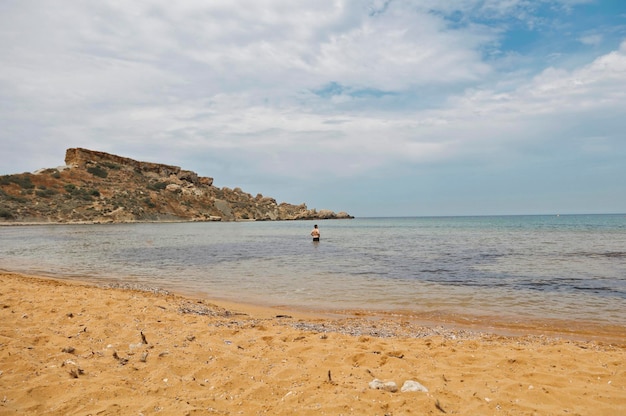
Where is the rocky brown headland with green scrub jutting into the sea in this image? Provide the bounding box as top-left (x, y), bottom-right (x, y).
top-left (0, 148), bottom-right (352, 223)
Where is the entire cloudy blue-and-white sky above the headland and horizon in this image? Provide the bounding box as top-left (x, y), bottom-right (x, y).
top-left (0, 0), bottom-right (626, 217)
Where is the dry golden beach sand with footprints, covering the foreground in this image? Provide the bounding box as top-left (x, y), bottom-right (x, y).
top-left (0, 272), bottom-right (626, 416)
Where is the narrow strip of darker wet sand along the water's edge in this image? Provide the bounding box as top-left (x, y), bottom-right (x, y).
top-left (0, 269), bottom-right (626, 347)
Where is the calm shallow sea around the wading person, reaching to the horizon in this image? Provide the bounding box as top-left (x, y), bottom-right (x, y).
top-left (0, 214), bottom-right (626, 326)
